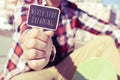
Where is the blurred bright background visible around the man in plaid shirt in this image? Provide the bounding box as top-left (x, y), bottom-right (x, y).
top-left (0, 0), bottom-right (120, 72)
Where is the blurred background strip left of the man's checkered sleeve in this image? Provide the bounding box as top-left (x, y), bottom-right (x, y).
top-left (0, 0), bottom-right (15, 72)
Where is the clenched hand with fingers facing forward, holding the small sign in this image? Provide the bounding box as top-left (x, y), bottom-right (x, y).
top-left (21, 28), bottom-right (53, 70)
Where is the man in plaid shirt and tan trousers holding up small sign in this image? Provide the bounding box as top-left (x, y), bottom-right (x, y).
top-left (1, 0), bottom-right (120, 80)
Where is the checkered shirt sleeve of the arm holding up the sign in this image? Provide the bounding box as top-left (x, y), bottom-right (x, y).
top-left (0, 0), bottom-right (41, 80)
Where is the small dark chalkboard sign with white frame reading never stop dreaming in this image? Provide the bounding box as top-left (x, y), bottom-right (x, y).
top-left (27, 4), bottom-right (60, 30)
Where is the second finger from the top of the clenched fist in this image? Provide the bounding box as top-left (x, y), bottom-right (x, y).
top-left (23, 38), bottom-right (47, 50)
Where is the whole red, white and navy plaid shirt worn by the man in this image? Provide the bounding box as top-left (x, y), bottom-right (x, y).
top-left (0, 0), bottom-right (120, 80)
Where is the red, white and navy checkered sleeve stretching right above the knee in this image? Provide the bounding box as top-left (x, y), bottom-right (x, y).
top-left (73, 9), bottom-right (120, 48)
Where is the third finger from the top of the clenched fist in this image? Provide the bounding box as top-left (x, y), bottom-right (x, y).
top-left (22, 49), bottom-right (46, 60)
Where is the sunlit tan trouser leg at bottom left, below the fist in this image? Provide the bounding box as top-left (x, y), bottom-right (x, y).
top-left (11, 67), bottom-right (55, 80)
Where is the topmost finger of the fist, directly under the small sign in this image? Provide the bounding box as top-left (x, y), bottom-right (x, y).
top-left (20, 28), bottom-right (54, 43)
